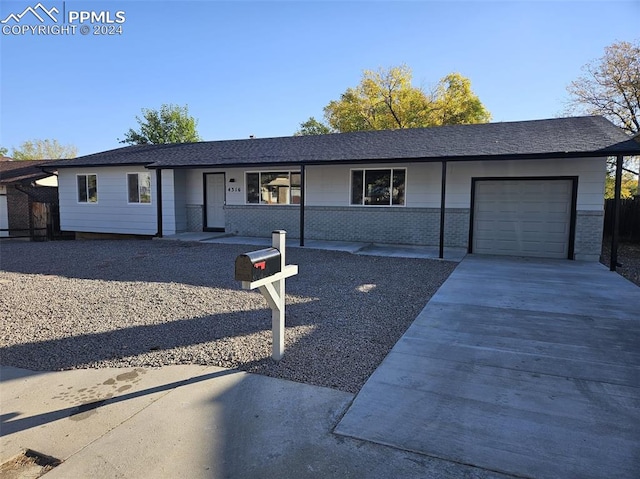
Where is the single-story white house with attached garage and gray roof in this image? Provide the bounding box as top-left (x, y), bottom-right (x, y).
top-left (46, 117), bottom-right (640, 260)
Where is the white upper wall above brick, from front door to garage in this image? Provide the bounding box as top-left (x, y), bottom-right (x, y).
top-left (178, 158), bottom-right (606, 211)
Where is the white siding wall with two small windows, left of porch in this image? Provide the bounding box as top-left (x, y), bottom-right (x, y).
top-left (58, 166), bottom-right (159, 235)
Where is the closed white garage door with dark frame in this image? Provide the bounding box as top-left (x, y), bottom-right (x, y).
top-left (473, 179), bottom-right (573, 259)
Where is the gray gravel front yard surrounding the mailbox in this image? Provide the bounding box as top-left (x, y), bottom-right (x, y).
top-left (0, 240), bottom-right (456, 393)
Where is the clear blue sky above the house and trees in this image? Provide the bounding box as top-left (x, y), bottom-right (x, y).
top-left (0, 0), bottom-right (640, 155)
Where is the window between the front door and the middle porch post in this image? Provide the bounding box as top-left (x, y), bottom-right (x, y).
top-left (246, 171), bottom-right (301, 205)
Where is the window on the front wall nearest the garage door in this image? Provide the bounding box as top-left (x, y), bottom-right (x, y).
top-left (351, 168), bottom-right (407, 206)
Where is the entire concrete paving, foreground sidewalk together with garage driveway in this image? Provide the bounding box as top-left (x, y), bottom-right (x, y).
top-left (0, 256), bottom-right (640, 479)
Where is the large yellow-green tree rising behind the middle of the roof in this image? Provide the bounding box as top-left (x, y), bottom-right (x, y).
top-left (296, 65), bottom-right (491, 135)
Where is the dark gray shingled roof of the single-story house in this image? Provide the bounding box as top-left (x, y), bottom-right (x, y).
top-left (47, 116), bottom-right (640, 168)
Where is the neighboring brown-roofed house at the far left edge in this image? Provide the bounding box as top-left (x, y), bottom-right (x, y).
top-left (0, 157), bottom-right (58, 237)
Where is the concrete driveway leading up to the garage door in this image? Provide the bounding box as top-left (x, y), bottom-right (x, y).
top-left (335, 256), bottom-right (640, 479)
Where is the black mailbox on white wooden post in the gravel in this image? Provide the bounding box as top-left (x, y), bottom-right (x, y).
top-left (236, 230), bottom-right (298, 361)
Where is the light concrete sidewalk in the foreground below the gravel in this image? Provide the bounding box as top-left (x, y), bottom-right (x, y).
top-left (0, 366), bottom-right (505, 479)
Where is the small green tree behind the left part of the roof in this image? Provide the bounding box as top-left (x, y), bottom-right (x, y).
top-left (118, 104), bottom-right (201, 145)
